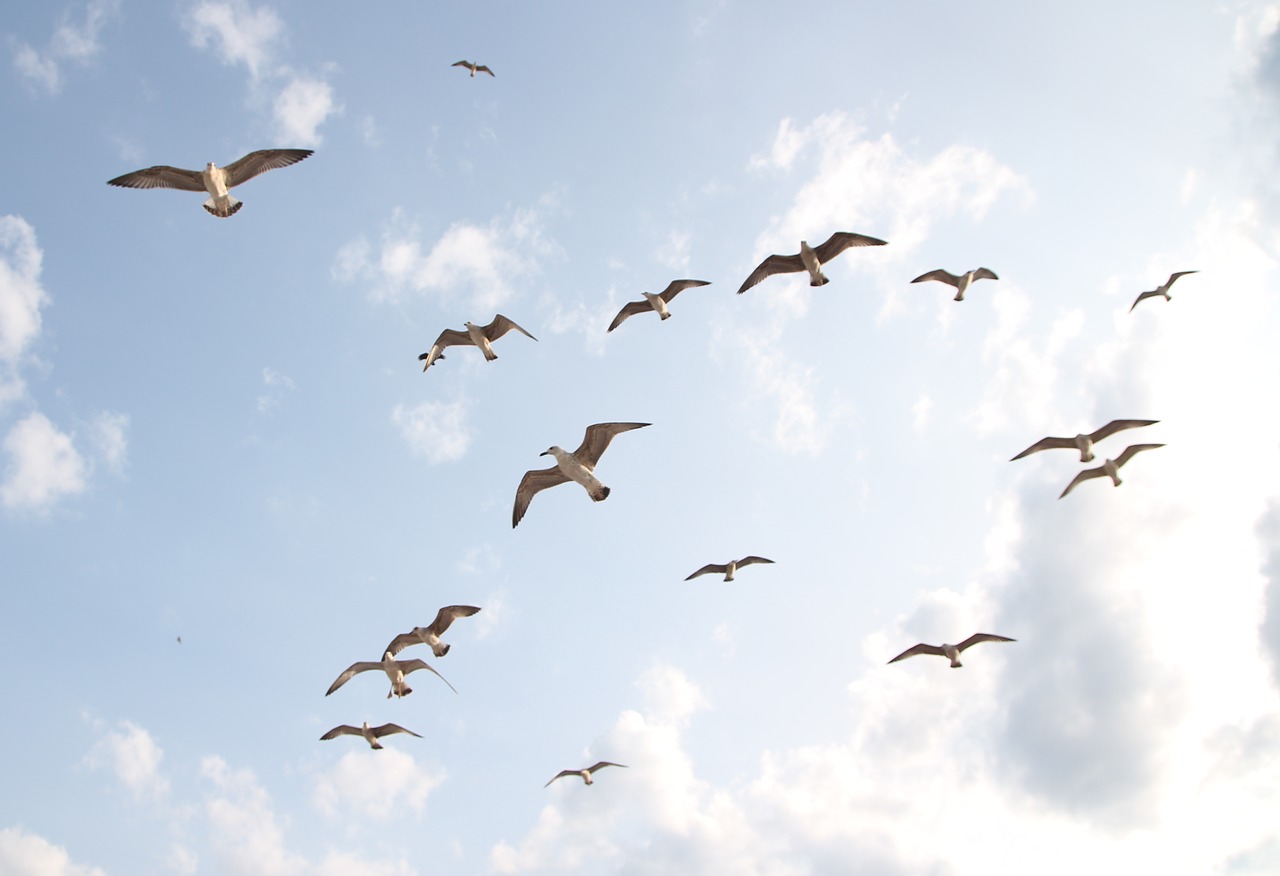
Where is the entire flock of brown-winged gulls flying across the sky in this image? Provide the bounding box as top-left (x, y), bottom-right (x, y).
top-left (108, 54), bottom-right (1197, 788)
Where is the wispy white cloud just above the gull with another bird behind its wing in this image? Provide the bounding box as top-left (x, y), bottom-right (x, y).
top-left (333, 197), bottom-right (559, 312)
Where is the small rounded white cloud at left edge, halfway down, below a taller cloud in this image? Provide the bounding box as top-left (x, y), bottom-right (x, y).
top-left (0, 412), bottom-right (87, 511)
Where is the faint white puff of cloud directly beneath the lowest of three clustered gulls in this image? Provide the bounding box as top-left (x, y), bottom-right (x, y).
top-left (311, 735), bottom-right (444, 820)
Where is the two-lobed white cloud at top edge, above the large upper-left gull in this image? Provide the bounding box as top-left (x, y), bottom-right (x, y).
top-left (183, 0), bottom-right (342, 146)
